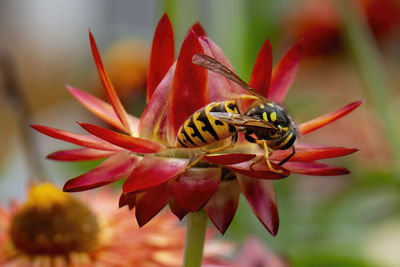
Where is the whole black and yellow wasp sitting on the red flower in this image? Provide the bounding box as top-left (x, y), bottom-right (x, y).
top-left (175, 54), bottom-right (297, 174)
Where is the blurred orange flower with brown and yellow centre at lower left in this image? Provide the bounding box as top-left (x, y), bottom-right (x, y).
top-left (0, 183), bottom-right (233, 267)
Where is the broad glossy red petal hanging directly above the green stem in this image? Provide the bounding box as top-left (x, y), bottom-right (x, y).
top-left (170, 168), bottom-right (221, 211)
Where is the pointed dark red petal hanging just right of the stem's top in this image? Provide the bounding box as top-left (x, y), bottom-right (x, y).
top-left (204, 180), bottom-right (240, 234)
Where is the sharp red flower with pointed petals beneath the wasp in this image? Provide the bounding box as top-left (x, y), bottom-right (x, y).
top-left (32, 15), bottom-right (361, 235)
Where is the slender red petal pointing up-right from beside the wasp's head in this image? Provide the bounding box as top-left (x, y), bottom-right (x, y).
top-left (298, 100), bottom-right (364, 135)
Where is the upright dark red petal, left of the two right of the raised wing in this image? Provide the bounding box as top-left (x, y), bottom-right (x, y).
top-left (249, 39), bottom-right (272, 97)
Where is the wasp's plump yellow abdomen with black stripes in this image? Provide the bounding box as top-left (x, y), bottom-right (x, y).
top-left (175, 101), bottom-right (239, 148)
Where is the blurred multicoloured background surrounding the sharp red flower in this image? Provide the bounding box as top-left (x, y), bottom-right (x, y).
top-left (0, 0), bottom-right (400, 266)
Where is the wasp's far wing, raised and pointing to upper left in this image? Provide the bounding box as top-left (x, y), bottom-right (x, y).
top-left (192, 54), bottom-right (267, 100)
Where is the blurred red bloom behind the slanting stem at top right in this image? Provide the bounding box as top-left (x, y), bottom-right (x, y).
top-left (285, 0), bottom-right (400, 56)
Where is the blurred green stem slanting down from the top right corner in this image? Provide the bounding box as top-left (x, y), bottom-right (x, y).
top-left (336, 0), bottom-right (400, 177)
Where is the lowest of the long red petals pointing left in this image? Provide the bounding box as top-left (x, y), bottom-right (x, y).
top-left (64, 152), bottom-right (139, 192)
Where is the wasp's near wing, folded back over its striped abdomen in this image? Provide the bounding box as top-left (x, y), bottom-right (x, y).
top-left (208, 112), bottom-right (276, 129)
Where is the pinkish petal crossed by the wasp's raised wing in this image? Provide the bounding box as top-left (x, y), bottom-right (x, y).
top-left (199, 36), bottom-right (245, 104)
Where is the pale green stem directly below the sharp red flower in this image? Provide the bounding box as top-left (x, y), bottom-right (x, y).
top-left (182, 210), bottom-right (207, 267)
